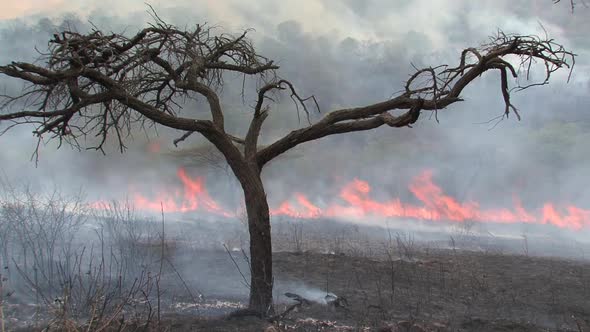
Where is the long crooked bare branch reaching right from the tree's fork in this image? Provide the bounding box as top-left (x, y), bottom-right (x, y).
top-left (257, 31), bottom-right (575, 167)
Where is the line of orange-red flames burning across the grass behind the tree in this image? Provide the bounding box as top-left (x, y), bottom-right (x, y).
top-left (91, 168), bottom-right (590, 230)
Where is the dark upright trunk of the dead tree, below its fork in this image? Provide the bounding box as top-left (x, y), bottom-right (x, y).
top-left (239, 170), bottom-right (273, 316)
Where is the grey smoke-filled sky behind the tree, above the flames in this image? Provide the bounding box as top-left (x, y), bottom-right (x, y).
top-left (0, 0), bottom-right (590, 237)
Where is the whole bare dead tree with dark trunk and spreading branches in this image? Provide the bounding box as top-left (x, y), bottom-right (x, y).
top-left (0, 14), bottom-right (574, 315)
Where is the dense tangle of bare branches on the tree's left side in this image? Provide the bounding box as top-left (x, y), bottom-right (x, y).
top-left (0, 20), bottom-right (278, 155)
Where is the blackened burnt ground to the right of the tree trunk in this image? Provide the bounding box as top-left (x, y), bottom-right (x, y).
top-left (276, 250), bottom-right (590, 331)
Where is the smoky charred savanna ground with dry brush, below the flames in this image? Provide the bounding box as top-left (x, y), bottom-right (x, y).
top-left (2, 202), bottom-right (590, 332)
